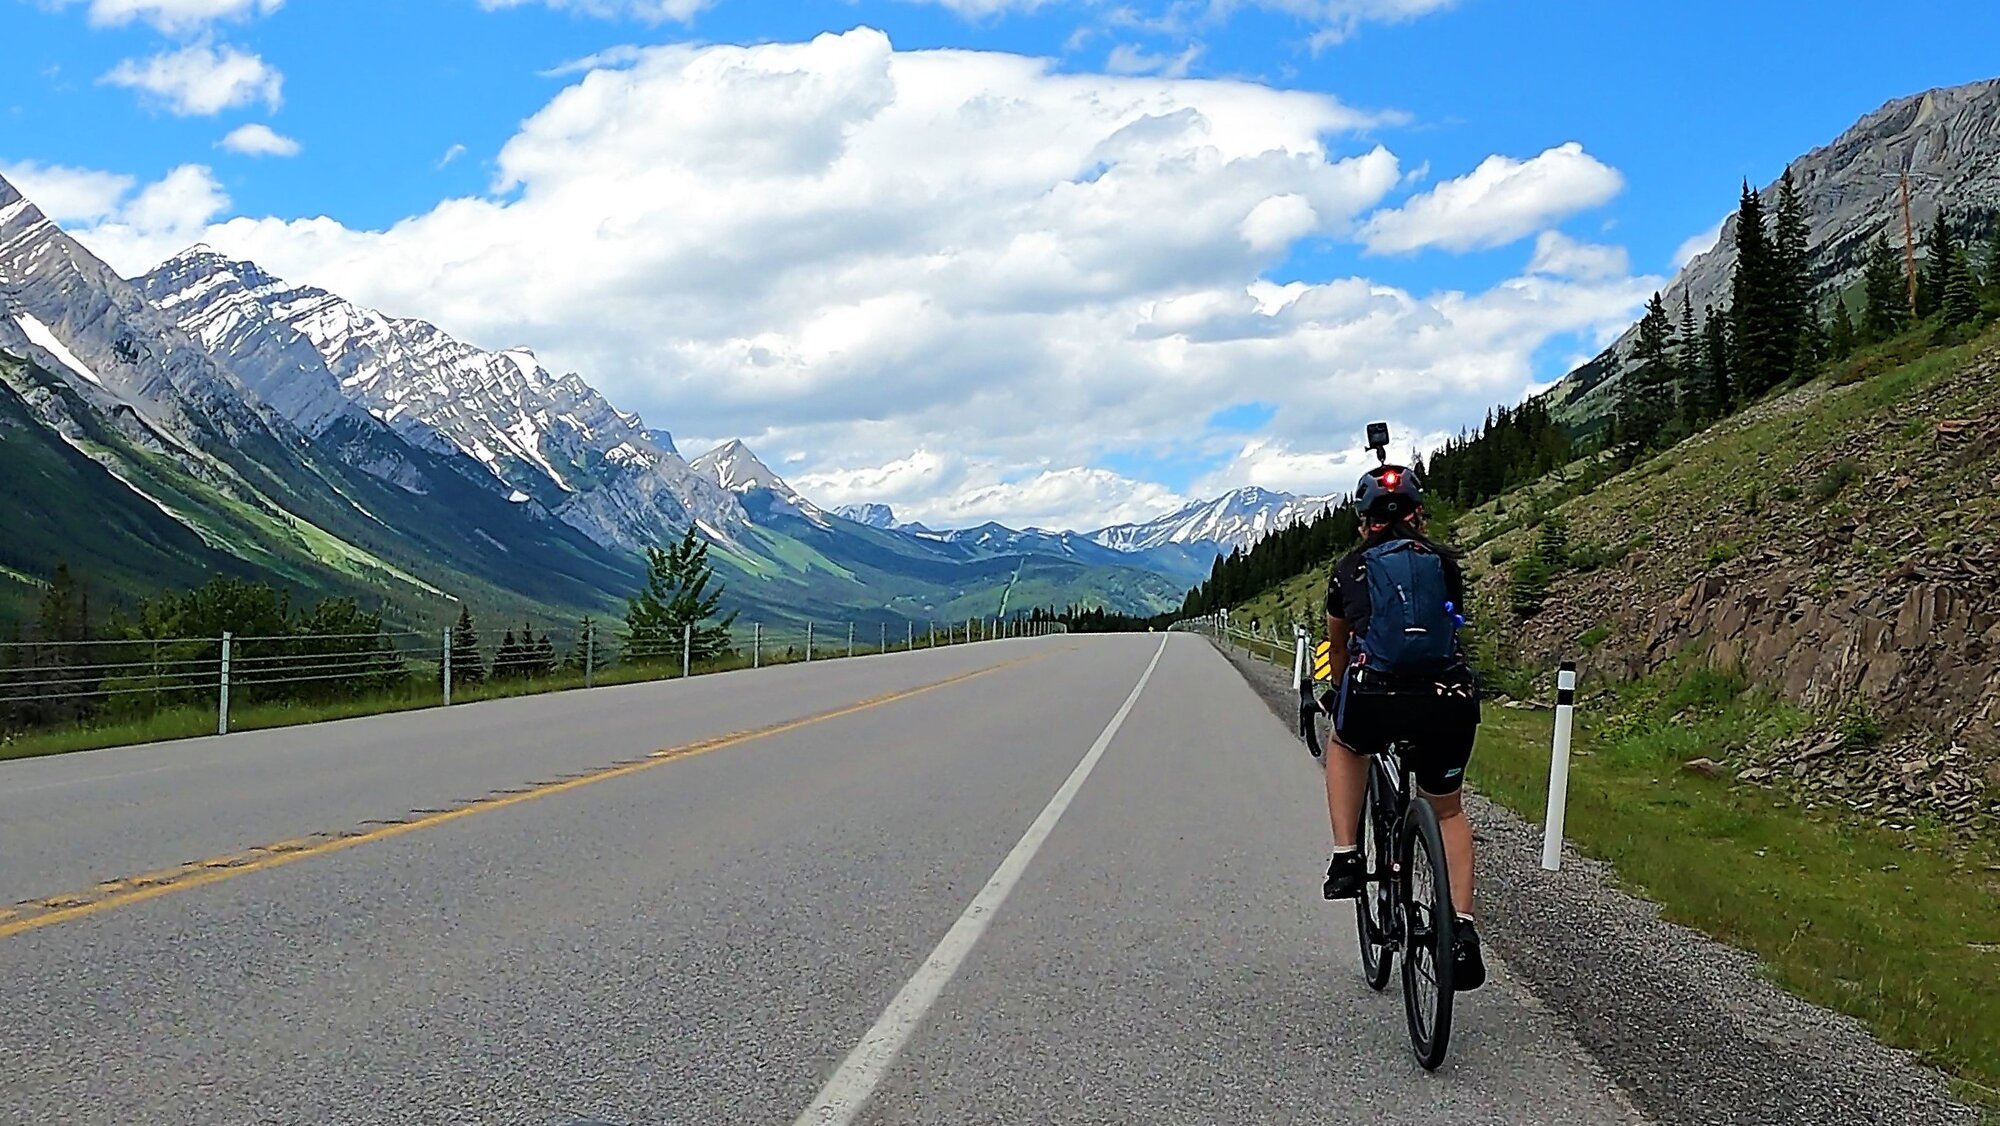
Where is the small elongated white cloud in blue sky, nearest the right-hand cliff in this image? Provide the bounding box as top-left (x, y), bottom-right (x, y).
top-left (1362, 142), bottom-right (1624, 254)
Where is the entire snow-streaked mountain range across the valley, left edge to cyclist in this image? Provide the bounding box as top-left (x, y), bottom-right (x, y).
top-left (0, 180), bottom-right (1360, 636)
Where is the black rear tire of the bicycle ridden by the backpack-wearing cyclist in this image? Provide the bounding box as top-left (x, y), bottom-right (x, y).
top-left (1396, 796), bottom-right (1458, 1072)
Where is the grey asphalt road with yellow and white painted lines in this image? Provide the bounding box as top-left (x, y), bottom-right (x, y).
top-left (0, 636), bottom-right (1636, 1126)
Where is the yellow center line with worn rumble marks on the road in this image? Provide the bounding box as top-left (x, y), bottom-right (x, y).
top-left (0, 654), bottom-right (1050, 938)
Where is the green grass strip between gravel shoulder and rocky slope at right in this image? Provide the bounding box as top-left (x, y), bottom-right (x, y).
top-left (1468, 692), bottom-right (2000, 1120)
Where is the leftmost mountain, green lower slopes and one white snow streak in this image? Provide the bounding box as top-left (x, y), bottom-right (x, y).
top-left (0, 172), bottom-right (634, 620)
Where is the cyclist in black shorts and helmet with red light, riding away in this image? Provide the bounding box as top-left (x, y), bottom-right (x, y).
top-left (1326, 464), bottom-right (1486, 990)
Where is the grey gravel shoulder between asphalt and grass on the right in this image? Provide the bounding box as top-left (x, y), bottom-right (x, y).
top-left (1228, 640), bottom-right (1980, 1126)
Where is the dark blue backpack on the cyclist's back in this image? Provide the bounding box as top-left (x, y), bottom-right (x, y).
top-left (1354, 540), bottom-right (1458, 676)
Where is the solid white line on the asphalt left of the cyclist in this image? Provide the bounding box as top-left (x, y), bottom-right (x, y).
top-left (794, 636), bottom-right (1168, 1126)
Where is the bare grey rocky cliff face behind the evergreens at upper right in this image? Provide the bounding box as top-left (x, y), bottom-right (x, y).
top-left (1550, 78), bottom-right (2000, 420)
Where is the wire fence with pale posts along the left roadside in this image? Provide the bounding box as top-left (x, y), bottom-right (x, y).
top-left (0, 618), bottom-right (1068, 744)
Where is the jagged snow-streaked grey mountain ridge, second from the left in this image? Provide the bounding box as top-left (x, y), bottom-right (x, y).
top-left (138, 246), bottom-right (744, 548)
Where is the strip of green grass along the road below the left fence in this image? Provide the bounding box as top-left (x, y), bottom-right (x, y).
top-left (0, 642), bottom-right (966, 762)
